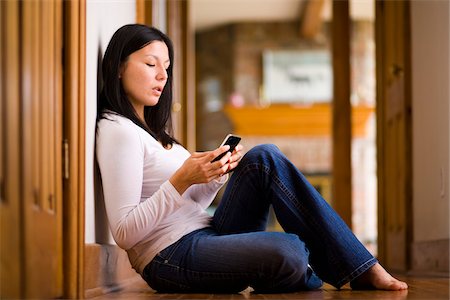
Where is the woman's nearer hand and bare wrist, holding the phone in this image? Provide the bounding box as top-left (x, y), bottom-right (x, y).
top-left (169, 145), bottom-right (231, 195)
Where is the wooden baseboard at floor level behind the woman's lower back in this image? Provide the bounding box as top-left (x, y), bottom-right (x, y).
top-left (84, 244), bottom-right (148, 298)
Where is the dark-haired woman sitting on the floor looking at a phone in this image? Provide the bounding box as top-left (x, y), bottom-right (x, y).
top-left (96, 25), bottom-right (407, 293)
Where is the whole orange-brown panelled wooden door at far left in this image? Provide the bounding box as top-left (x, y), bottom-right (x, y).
top-left (1, 0), bottom-right (63, 299)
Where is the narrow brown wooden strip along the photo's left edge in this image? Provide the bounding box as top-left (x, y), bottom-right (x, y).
top-left (0, 1), bottom-right (25, 299)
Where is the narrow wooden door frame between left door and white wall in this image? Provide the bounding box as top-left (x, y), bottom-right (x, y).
top-left (64, 0), bottom-right (86, 299)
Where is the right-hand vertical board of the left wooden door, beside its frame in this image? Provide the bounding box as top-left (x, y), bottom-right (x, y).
top-left (21, 1), bottom-right (62, 298)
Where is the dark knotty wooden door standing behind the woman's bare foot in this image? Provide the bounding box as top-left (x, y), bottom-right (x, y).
top-left (376, 1), bottom-right (412, 271)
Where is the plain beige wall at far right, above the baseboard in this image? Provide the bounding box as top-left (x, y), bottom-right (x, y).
top-left (411, 1), bottom-right (450, 242)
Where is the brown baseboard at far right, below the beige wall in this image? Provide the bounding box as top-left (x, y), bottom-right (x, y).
top-left (411, 239), bottom-right (450, 277)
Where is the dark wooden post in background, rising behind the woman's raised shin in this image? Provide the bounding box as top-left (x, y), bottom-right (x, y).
top-left (332, 0), bottom-right (352, 228)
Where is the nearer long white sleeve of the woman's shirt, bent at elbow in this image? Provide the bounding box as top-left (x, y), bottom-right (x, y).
top-left (96, 120), bottom-right (192, 250)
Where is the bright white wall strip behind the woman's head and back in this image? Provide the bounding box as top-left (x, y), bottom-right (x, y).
top-left (85, 0), bottom-right (136, 243)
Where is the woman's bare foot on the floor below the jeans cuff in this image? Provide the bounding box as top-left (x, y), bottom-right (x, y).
top-left (350, 263), bottom-right (408, 291)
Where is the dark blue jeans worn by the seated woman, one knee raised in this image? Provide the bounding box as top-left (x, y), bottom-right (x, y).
top-left (143, 145), bottom-right (377, 293)
